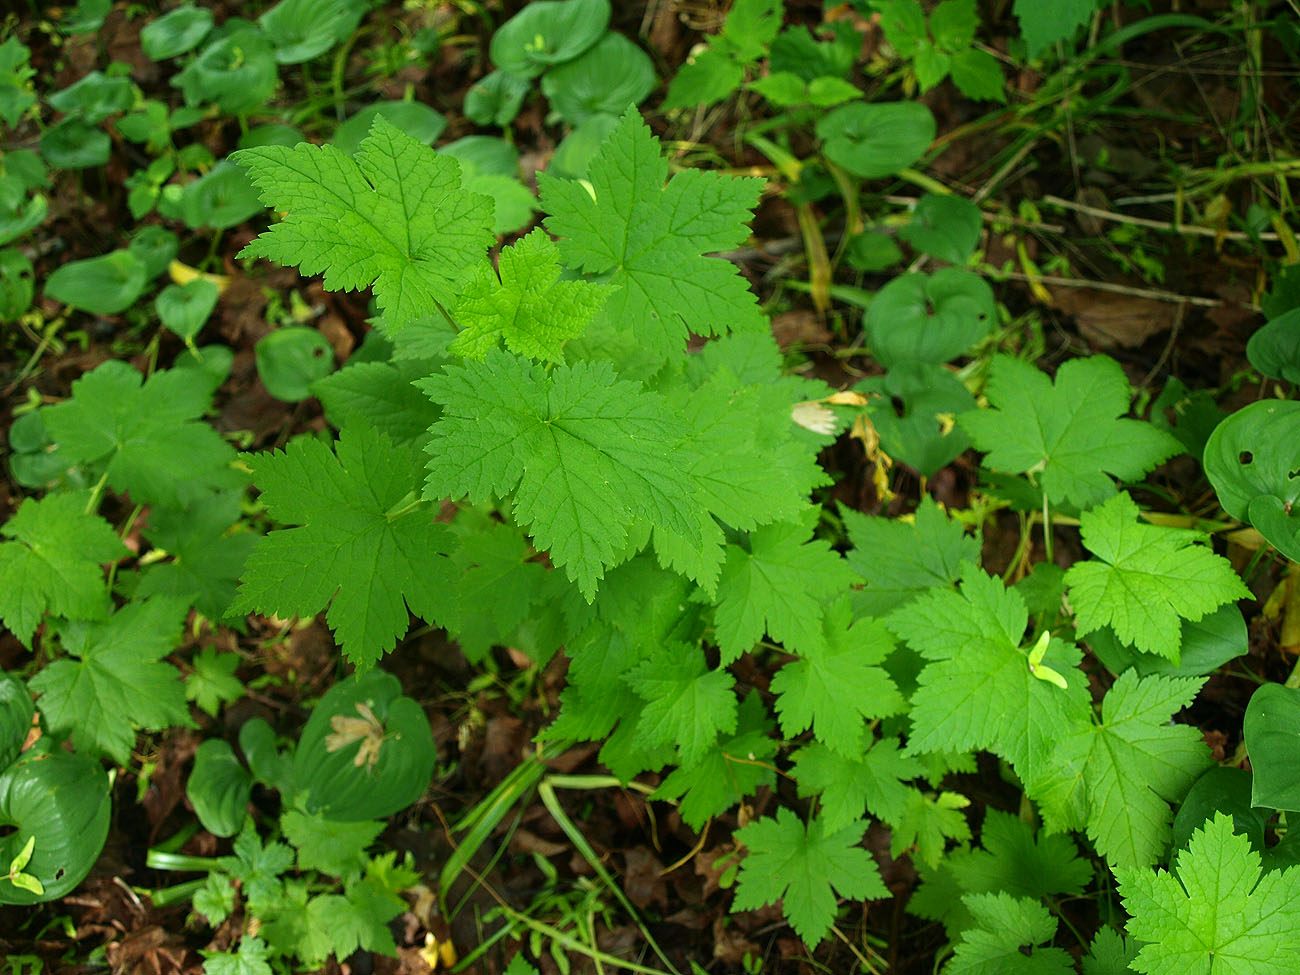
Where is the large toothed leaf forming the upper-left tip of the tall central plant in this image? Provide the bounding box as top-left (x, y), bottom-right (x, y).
top-left (230, 116), bottom-right (493, 332)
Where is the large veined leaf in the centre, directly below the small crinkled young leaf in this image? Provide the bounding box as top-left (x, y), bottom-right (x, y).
top-left (417, 351), bottom-right (707, 601)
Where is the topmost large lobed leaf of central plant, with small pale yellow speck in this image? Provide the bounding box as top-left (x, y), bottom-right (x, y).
top-left (538, 112), bottom-right (767, 359)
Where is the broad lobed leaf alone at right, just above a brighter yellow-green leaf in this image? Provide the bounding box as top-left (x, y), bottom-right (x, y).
top-left (958, 355), bottom-right (1183, 508)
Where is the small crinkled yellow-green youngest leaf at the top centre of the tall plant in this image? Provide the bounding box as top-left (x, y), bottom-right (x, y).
top-left (449, 229), bottom-right (610, 363)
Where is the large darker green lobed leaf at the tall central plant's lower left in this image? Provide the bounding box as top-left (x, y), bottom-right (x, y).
top-left (233, 424), bottom-right (454, 667)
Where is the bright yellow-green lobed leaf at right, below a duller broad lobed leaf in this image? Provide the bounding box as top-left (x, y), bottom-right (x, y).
top-left (1065, 494), bottom-right (1251, 662)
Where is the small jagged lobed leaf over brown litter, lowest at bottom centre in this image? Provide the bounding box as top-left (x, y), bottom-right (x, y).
top-left (732, 809), bottom-right (889, 946)
